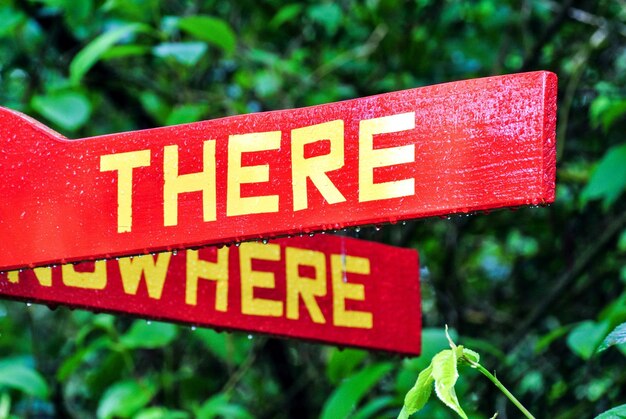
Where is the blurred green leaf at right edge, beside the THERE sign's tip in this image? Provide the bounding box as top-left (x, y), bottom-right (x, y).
top-left (582, 143), bottom-right (626, 208)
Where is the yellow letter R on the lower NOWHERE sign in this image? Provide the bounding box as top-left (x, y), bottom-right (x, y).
top-left (285, 247), bottom-right (326, 323)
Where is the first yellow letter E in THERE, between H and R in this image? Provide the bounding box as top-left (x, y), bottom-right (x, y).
top-left (226, 131), bottom-right (281, 217)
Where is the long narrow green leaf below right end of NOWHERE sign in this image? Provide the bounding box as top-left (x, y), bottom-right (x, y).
top-left (320, 363), bottom-right (393, 419)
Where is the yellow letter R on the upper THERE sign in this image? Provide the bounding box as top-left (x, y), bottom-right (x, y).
top-left (291, 119), bottom-right (346, 211)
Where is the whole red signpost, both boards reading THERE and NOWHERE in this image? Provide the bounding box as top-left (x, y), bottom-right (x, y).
top-left (0, 72), bottom-right (556, 355)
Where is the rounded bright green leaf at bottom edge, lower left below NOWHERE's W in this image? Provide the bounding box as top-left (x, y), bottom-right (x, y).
top-left (97, 380), bottom-right (157, 419)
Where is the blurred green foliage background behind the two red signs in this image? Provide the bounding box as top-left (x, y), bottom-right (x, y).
top-left (0, 0), bottom-right (626, 419)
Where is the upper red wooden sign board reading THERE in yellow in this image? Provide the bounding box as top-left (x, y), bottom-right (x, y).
top-left (0, 72), bottom-right (556, 270)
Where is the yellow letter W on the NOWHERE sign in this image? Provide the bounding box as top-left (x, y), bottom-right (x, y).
top-left (118, 253), bottom-right (172, 300)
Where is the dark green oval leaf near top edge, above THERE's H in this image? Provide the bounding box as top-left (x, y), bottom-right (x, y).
top-left (178, 16), bottom-right (237, 54)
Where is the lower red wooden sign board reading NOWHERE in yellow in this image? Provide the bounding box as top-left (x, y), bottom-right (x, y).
top-left (0, 234), bottom-right (421, 355)
